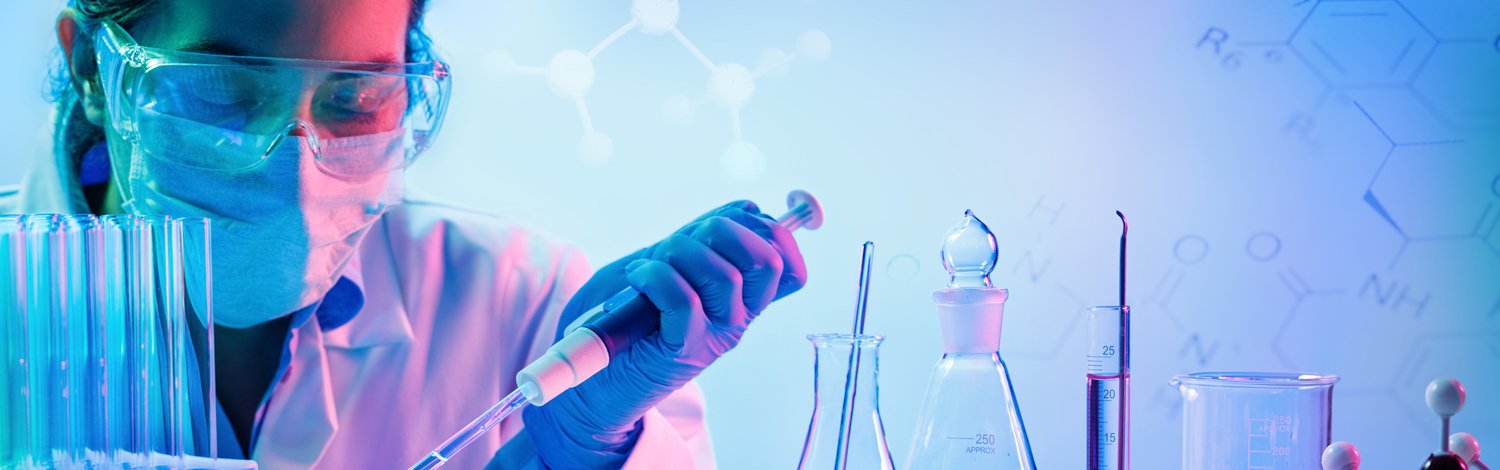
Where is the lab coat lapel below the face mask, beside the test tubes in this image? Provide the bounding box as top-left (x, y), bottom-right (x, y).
top-left (251, 315), bottom-right (339, 468)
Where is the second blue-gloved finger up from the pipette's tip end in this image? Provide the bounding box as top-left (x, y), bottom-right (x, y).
top-left (657, 234), bottom-right (750, 332)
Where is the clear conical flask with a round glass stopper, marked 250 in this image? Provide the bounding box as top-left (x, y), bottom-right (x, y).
top-left (906, 212), bottom-right (1037, 470)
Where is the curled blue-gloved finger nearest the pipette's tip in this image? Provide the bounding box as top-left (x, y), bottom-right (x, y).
top-left (626, 260), bottom-right (705, 351)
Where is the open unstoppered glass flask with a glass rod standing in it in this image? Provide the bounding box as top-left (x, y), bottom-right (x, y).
top-left (797, 333), bottom-right (896, 470)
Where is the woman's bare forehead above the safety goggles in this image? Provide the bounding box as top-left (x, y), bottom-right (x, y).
top-left (131, 0), bottom-right (411, 62)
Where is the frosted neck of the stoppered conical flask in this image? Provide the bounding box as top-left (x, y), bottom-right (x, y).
top-left (933, 288), bottom-right (1010, 354)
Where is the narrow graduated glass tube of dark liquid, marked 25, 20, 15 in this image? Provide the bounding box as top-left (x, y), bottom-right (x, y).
top-left (1088, 305), bottom-right (1130, 470)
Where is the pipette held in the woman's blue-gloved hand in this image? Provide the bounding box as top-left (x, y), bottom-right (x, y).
top-left (411, 189), bottom-right (824, 470)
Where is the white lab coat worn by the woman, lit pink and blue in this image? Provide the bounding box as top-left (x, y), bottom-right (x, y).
top-left (0, 134), bottom-right (714, 468)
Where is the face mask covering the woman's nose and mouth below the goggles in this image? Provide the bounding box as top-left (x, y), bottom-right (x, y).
top-left (110, 114), bottom-right (404, 327)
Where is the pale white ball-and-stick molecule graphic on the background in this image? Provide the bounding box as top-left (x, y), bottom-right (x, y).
top-left (498, 0), bottom-right (831, 180)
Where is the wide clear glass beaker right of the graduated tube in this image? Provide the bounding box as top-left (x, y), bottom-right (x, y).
top-left (1172, 372), bottom-right (1338, 470)
